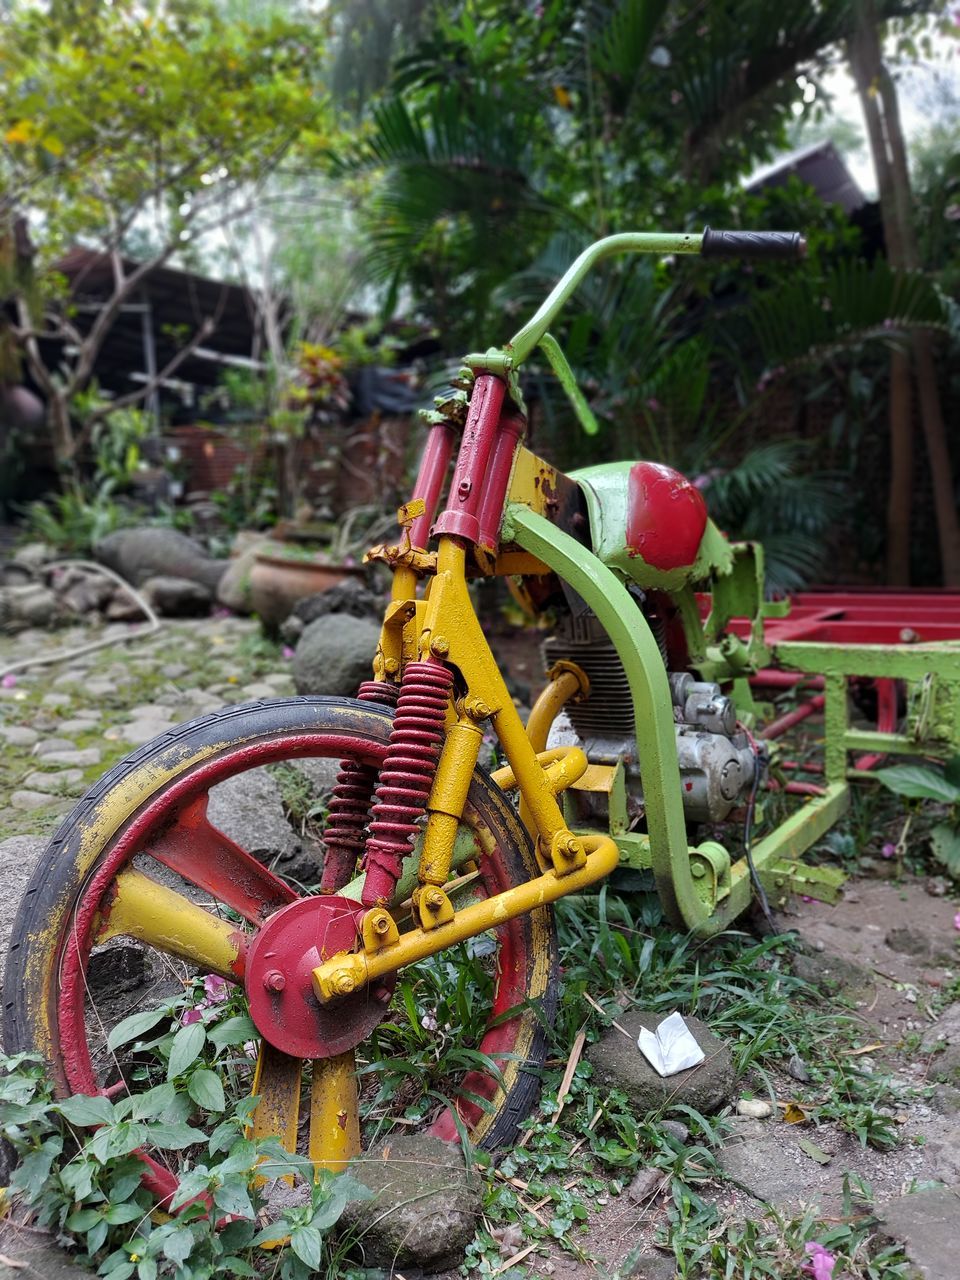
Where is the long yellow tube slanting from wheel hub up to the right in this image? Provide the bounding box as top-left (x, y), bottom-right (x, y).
top-left (314, 835), bottom-right (620, 1004)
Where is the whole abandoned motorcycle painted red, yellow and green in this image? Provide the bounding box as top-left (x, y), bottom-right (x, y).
top-left (5, 229), bottom-right (960, 1198)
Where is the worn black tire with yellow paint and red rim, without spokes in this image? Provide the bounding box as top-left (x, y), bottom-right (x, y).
top-left (4, 698), bottom-right (558, 1147)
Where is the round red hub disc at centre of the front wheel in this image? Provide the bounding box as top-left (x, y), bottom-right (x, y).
top-left (244, 895), bottom-right (397, 1057)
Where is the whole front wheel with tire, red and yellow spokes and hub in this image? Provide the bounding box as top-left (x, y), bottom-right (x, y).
top-left (4, 698), bottom-right (557, 1197)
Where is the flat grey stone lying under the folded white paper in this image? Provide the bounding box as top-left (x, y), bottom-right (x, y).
top-left (588, 1010), bottom-right (736, 1115)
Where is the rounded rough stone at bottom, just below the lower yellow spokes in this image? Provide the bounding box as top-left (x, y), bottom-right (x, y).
top-left (340, 1134), bottom-right (481, 1272)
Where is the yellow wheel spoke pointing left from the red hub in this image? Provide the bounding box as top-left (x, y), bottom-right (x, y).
top-left (96, 867), bottom-right (244, 980)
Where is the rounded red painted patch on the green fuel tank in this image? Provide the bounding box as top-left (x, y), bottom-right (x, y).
top-left (627, 462), bottom-right (707, 570)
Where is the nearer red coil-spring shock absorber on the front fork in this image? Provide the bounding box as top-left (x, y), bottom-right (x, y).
top-left (361, 662), bottom-right (453, 906)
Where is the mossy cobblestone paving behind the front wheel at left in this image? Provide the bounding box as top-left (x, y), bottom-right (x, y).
top-left (0, 617), bottom-right (293, 951)
